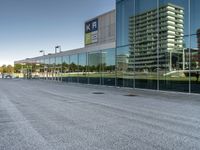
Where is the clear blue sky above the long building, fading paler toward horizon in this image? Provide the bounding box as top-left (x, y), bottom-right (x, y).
top-left (0, 0), bottom-right (115, 65)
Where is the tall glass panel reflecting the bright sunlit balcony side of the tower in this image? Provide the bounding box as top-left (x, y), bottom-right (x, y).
top-left (158, 0), bottom-right (190, 92)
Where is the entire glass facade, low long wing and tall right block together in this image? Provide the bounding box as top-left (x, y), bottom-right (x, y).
top-left (14, 0), bottom-right (200, 93)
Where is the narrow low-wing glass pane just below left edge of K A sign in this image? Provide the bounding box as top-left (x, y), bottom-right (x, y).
top-left (78, 53), bottom-right (88, 84)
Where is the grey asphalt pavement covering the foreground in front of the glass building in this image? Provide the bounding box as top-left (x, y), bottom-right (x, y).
top-left (0, 79), bottom-right (200, 150)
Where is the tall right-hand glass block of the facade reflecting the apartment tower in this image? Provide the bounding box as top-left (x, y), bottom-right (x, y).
top-left (116, 0), bottom-right (200, 93)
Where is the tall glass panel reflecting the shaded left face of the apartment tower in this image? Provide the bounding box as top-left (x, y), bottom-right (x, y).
top-left (134, 0), bottom-right (158, 89)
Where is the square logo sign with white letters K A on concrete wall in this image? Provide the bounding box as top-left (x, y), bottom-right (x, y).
top-left (85, 18), bottom-right (98, 45)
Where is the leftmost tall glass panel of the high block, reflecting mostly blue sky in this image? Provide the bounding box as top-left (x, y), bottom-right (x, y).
top-left (116, 0), bottom-right (135, 87)
